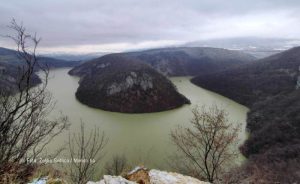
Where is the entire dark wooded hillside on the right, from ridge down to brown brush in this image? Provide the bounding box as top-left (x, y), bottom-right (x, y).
top-left (192, 47), bottom-right (300, 163)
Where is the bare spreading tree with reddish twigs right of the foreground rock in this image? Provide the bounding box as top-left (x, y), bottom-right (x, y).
top-left (171, 106), bottom-right (240, 182)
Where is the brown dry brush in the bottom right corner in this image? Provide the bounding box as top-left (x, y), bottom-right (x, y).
top-left (220, 155), bottom-right (300, 184)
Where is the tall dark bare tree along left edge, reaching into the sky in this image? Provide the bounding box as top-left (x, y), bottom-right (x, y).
top-left (0, 20), bottom-right (68, 180)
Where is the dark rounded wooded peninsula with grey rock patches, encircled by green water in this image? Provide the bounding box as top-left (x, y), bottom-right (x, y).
top-left (69, 54), bottom-right (189, 113)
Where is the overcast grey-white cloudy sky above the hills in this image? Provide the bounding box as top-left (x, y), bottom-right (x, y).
top-left (0, 0), bottom-right (300, 52)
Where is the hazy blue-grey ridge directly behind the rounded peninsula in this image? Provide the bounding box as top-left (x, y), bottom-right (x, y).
top-left (69, 47), bottom-right (255, 76)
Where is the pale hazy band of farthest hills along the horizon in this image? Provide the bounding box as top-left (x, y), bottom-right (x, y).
top-left (32, 37), bottom-right (300, 61)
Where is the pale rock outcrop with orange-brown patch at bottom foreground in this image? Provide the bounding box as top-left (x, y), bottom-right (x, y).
top-left (88, 167), bottom-right (209, 184)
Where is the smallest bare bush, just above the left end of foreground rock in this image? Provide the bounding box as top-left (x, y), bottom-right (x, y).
top-left (104, 155), bottom-right (128, 176)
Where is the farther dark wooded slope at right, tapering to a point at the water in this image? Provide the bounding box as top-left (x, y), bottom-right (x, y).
top-left (192, 47), bottom-right (300, 106)
